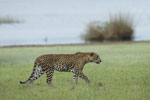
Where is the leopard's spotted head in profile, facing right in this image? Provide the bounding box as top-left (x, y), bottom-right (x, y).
top-left (88, 52), bottom-right (102, 64)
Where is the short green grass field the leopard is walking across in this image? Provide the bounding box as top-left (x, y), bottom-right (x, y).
top-left (0, 43), bottom-right (150, 100)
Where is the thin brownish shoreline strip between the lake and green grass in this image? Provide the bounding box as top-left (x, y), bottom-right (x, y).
top-left (0, 41), bottom-right (150, 48)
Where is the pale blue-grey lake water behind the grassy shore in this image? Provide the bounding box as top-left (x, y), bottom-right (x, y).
top-left (0, 0), bottom-right (150, 46)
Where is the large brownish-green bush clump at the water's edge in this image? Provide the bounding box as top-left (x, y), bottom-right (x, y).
top-left (82, 14), bottom-right (134, 41)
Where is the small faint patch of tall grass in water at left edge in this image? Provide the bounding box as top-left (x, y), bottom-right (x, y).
top-left (0, 16), bottom-right (21, 25)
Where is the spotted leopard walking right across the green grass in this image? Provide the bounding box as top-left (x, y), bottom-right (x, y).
top-left (20, 52), bottom-right (102, 88)
